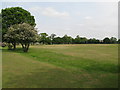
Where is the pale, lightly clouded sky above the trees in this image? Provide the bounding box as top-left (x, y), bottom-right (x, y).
top-left (2, 2), bottom-right (118, 39)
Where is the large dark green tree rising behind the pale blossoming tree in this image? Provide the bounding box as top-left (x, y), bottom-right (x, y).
top-left (2, 7), bottom-right (36, 41)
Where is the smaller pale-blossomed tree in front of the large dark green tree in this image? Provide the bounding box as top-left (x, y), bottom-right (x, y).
top-left (5, 23), bottom-right (37, 52)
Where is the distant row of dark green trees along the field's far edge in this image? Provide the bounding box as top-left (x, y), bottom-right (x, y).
top-left (38, 33), bottom-right (120, 44)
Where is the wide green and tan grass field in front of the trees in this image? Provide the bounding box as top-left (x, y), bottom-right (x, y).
top-left (3, 44), bottom-right (118, 88)
